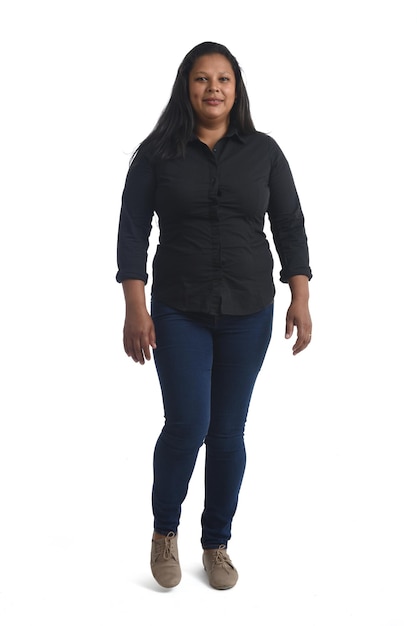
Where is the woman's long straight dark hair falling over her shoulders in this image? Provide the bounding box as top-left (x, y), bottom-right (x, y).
top-left (131, 41), bottom-right (255, 164)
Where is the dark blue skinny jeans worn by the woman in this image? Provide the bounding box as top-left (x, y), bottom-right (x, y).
top-left (152, 301), bottom-right (273, 548)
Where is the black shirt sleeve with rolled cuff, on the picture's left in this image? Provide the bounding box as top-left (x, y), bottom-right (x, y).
top-left (116, 156), bottom-right (155, 284)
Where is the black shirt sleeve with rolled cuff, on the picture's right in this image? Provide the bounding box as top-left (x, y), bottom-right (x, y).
top-left (268, 141), bottom-right (312, 283)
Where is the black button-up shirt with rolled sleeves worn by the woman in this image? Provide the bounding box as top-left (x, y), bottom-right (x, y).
top-left (116, 130), bottom-right (311, 315)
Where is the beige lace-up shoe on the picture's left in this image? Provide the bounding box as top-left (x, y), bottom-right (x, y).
top-left (151, 532), bottom-right (181, 588)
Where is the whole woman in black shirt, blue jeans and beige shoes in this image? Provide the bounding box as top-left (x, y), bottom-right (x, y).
top-left (117, 42), bottom-right (311, 589)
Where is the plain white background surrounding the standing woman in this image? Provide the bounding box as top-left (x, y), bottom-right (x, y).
top-left (0, 0), bottom-right (417, 626)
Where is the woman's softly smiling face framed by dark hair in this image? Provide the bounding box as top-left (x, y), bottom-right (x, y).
top-left (188, 54), bottom-right (236, 125)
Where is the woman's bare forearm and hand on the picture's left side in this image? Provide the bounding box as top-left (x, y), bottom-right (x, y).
top-left (122, 280), bottom-right (156, 365)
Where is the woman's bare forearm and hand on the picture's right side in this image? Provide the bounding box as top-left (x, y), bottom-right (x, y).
top-left (285, 275), bottom-right (312, 356)
